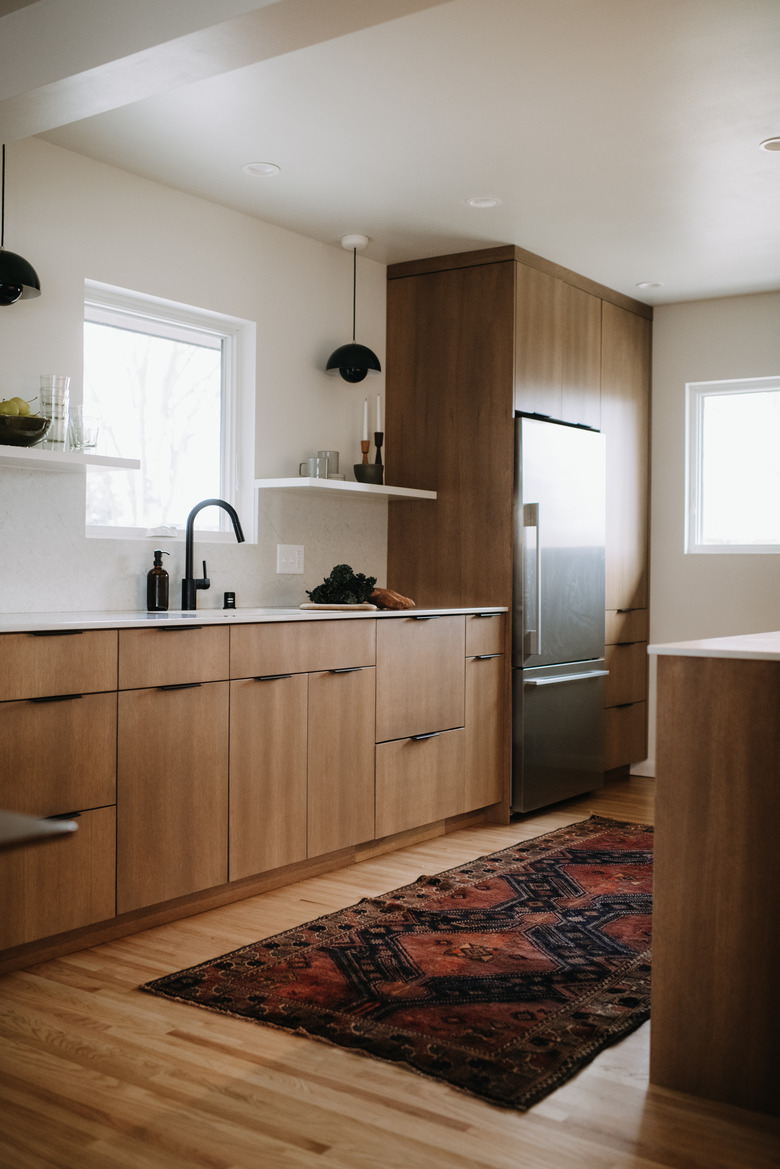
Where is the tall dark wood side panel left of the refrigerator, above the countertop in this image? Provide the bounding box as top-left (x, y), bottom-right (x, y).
top-left (386, 260), bottom-right (516, 607)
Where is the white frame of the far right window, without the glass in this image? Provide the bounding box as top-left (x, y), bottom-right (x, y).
top-left (685, 375), bottom-right (780, 555)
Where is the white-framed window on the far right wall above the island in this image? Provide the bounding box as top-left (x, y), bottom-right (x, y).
top-left (685, 376), bottom-right (780, 553)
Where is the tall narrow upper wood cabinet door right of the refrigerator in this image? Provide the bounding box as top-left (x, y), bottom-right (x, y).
top-left (601, 302), bottom-right (651, 609)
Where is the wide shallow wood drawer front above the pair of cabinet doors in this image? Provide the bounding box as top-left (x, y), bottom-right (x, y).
top-left (230, 617), bottom-right (377, 678)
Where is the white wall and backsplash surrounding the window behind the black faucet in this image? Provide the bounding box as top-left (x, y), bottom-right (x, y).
top-left (0, 139), bottom-right (387, 613)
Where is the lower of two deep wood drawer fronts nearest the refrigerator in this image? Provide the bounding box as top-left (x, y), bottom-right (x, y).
top-left (377, 729), bottom-right (465, 837)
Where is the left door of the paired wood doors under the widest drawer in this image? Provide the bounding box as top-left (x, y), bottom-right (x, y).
top-left (228, 673), bottom-right (309, 880)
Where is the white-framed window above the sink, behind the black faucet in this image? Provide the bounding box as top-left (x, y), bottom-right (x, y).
top-left (84, 282), bottom-right (255, 539)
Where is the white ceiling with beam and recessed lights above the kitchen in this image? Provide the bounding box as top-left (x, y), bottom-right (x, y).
top-left (0, 0), bottom-right (780, 304)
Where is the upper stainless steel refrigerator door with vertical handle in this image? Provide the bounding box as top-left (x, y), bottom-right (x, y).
top-left (512, 417), bottom-right (606, 666)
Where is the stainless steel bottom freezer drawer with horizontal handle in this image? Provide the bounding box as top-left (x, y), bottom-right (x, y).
top-left (512, 659), bottom-right (607, 812)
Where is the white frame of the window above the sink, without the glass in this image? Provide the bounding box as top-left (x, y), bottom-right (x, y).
top-left (84, 279), bottom-right (257, 544)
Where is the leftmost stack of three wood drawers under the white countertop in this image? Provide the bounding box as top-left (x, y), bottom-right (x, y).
top-left (0, 630), bottom-right (117, 948)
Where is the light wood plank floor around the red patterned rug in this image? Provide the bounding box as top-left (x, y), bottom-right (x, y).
top-left (0, 777), bottom-right (780, 1169)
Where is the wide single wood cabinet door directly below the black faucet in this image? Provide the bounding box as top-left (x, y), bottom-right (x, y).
top-left (117, 682), bottom-right (229, 913)
